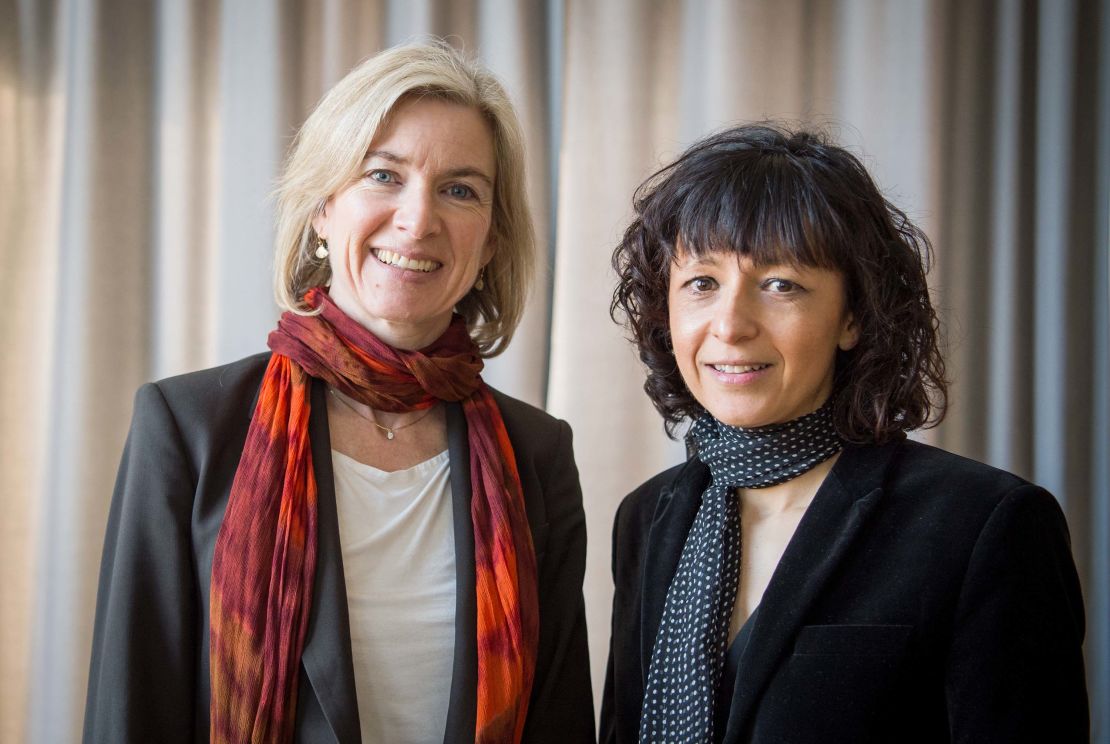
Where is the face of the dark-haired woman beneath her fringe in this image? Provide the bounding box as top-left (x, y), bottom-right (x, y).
top-left (668, 245), bottom-right (859, 428)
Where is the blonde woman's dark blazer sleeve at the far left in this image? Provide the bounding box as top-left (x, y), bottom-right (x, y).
top-left (83, 384), bottom-right (199, 744)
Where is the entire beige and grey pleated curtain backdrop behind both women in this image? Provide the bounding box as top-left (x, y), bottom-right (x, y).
top-left (0, 0), bottom-right (1110, 742)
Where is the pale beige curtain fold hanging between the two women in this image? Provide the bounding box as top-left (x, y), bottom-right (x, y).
top-left (547, 0), bottom-right (683, 708)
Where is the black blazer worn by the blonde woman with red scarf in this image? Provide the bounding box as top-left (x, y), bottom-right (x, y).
top-left (84, 353), bottom-right (594, 744)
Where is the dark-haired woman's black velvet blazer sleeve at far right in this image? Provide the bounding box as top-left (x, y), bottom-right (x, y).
top-left (946, 484), bottom-right (1089, 744)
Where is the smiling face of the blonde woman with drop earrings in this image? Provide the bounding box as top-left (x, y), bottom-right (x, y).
top-left (313, 98), bottom-right (496, 349)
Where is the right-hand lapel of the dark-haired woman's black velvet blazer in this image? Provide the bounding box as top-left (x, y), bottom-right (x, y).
top-left (724, 446), bottom-right (894, 742)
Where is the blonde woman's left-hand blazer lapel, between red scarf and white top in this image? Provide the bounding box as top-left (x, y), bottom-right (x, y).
top-left (301, 380), bottom-right (362, 743)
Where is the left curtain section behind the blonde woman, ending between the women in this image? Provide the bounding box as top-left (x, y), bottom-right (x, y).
top-left (0, 0), bottom-right (551, 742)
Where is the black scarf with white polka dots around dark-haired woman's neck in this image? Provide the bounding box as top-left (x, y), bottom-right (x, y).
top-left (639, 403), bottom-right (842, 744)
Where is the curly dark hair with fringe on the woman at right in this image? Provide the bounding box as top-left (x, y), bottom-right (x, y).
top-left (609, 124), bottom-right (948, 443)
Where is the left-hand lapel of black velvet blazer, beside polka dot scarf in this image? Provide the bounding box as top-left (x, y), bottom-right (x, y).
top-left (640, 460), bottom-right (709, 686)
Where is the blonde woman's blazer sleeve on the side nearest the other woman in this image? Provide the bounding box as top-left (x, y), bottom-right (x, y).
top-left (523, 421), bottom-right (595, 744)
